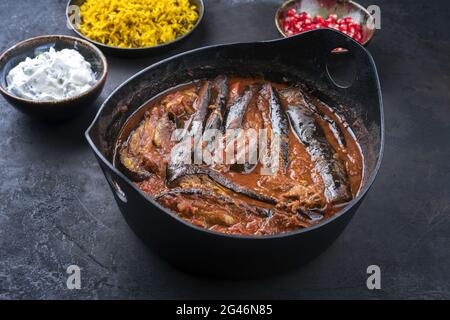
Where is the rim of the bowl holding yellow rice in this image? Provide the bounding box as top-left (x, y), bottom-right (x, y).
top-left (65, 0), bottom-right (205, 53)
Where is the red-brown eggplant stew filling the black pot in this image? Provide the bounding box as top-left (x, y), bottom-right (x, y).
top-left (114, 76), bottom-right (363, 235)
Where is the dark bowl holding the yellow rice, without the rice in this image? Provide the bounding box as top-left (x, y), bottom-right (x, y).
top-left (66, 0), bottom-right (205, 58)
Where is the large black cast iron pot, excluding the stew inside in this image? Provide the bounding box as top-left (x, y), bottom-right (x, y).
top-left (86, 29), bottom-right (384, 277)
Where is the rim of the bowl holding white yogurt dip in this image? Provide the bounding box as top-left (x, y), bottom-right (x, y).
top-left (0, 35), bottom-right (108, 105)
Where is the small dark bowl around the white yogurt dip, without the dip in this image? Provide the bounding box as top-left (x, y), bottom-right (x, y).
top-left (0, 35), bottom-right (108, 121)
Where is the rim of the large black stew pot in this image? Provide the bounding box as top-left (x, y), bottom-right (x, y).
top-left (85, 29), bottom-right (385, 241)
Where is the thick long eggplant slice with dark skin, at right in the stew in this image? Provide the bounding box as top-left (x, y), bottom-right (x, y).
top-left (287, 105), bottom-right (352, 204)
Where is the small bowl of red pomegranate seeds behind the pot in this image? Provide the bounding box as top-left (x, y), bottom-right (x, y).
top-left (275, 0), bottom-right (375, 45)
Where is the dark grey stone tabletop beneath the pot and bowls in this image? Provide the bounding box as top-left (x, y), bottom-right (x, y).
top-left (0, 0), bottom-right (450, 299)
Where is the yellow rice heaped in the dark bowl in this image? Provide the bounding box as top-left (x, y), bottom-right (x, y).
top-left (79, 0), bottom-right (198, 48)
